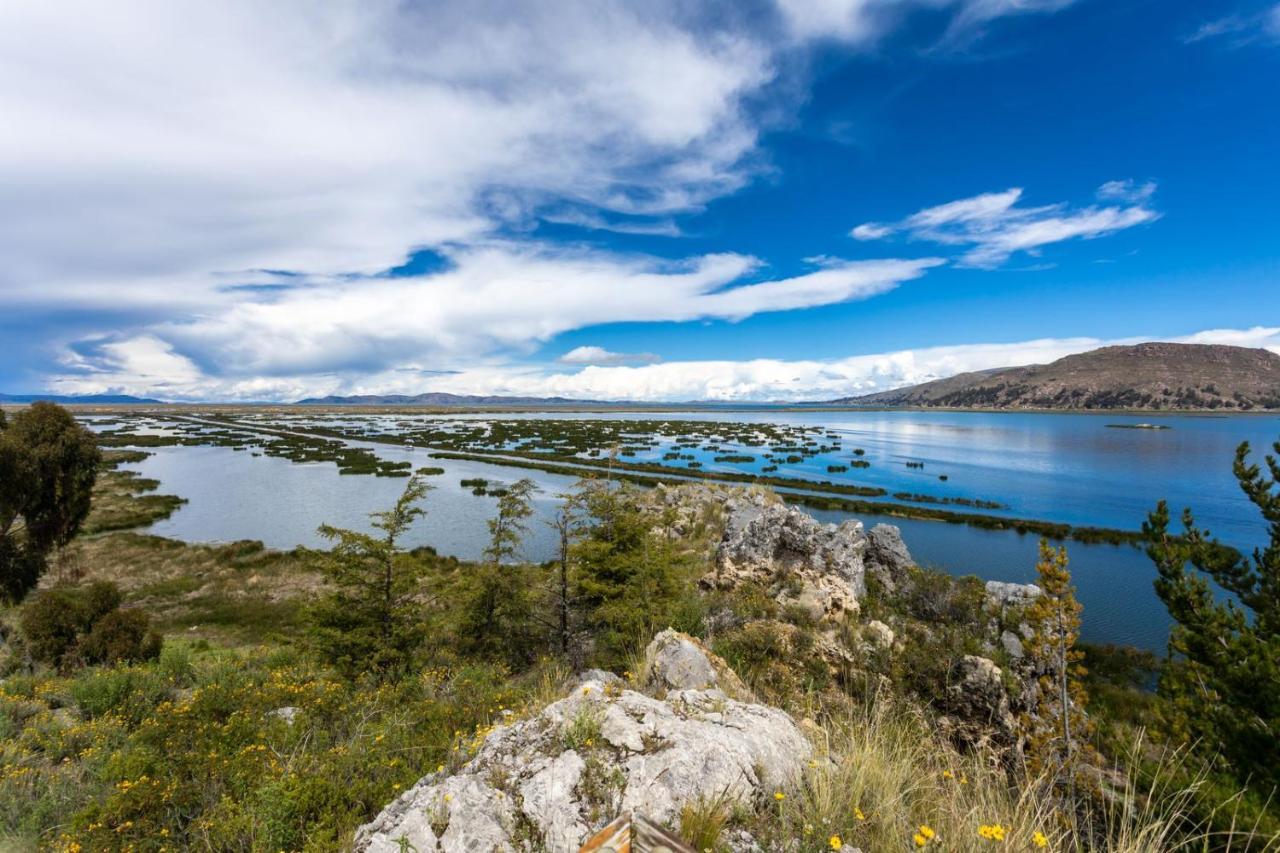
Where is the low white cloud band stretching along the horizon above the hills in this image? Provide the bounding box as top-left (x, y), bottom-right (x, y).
top-left (55, 327), bottom-right (1280, 402)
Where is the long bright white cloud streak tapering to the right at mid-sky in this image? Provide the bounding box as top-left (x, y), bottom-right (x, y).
top-left (49, 243), bottom-right (941, 377)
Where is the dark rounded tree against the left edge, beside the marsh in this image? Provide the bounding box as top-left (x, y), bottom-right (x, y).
top-left (0, 402), bottom-right (100, 601)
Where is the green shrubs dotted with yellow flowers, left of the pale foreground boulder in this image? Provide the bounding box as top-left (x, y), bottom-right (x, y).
top-left (0, 644), bottom-right (527, 853)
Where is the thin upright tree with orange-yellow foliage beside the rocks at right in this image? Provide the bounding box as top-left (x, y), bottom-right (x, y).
top-left (1023, 539), bottom-right (1089, 798)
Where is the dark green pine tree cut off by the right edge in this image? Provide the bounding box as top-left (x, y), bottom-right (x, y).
top-left (1143, 442), bottom-right (1280, 789)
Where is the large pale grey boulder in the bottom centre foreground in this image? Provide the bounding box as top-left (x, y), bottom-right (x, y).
top-left (356, 631), bottom-right (812, 853)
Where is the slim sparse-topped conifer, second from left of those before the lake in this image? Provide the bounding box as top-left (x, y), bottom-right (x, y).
top-left (461, 479), bottom-right (538, 667)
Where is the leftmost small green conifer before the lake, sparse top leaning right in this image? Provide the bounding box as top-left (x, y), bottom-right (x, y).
top-left (310, 476), bottom-right (431, 676)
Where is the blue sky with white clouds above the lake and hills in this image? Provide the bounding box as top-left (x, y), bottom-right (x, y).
top-left (0, 0), bottom-right (1280, 401)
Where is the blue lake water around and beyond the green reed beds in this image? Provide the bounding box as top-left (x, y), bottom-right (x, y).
top-left (102, 410), bottom-right (1280, 649)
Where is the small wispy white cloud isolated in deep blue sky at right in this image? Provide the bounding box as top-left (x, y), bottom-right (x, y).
top-left (850, 181), bottom-right (1160, 269)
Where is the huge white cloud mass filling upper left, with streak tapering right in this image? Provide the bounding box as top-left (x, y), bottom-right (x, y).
top-left (0, 0), bottom-right (1085, 396)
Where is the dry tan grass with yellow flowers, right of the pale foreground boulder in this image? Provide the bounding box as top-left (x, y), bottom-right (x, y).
top-left (747, 695), bottom-right (1280, 853)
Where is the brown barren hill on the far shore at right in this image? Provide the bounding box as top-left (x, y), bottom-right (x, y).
top-left (832, 343), bottom-right (1280, 411)
